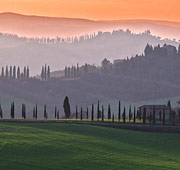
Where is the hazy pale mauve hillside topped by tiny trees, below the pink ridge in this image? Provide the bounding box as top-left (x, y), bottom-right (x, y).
top-left (0, 30), bottom-right (179, 75)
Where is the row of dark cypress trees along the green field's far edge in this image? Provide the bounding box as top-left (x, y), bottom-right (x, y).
top-left (0, 97), bottom-right (180, 126)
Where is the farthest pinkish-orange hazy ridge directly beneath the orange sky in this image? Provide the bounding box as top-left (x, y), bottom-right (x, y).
top-left (0, 13), bottom-right (180, 40)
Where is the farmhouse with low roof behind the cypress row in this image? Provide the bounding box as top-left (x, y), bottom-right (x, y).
top-left (139, 105), bottom-right (170, 120)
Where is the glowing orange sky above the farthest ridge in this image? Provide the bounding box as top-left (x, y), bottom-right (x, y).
top-left (0, 0), bottom-right (180, 22)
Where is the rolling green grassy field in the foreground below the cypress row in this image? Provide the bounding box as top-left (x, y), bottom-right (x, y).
top-left (0, 123), bottom-right (180, 170)
